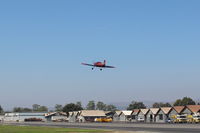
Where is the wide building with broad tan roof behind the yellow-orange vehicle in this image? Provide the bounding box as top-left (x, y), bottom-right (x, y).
top-left (77, 110), bottom-right (106, 122)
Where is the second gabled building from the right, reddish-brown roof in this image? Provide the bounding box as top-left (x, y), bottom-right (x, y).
top-left (169, 106), bottom-right (185, 119)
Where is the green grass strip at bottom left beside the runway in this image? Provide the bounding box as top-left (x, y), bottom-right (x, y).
top-left (0, 125), bottom-right (106, 133)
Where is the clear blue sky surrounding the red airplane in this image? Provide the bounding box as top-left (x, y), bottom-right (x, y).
top-left (0, 0), bottom-right (200, 108)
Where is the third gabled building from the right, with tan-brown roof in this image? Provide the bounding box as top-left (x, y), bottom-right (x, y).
top-left (156, 107), bottom-right (172, 123)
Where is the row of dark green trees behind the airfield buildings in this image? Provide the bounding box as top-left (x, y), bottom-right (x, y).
top-left (0, 97), bottom-right (200, 114)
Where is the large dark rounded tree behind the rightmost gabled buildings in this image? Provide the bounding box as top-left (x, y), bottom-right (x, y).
top-left (174, 97), bottom-right (196, 106)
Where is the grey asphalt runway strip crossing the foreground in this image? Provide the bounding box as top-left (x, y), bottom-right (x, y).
top-left (4, 122), bottom-right (200, 133)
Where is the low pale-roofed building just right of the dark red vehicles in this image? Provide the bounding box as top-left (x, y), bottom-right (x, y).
top-left (44, 112), bottom-right (68, 122)
